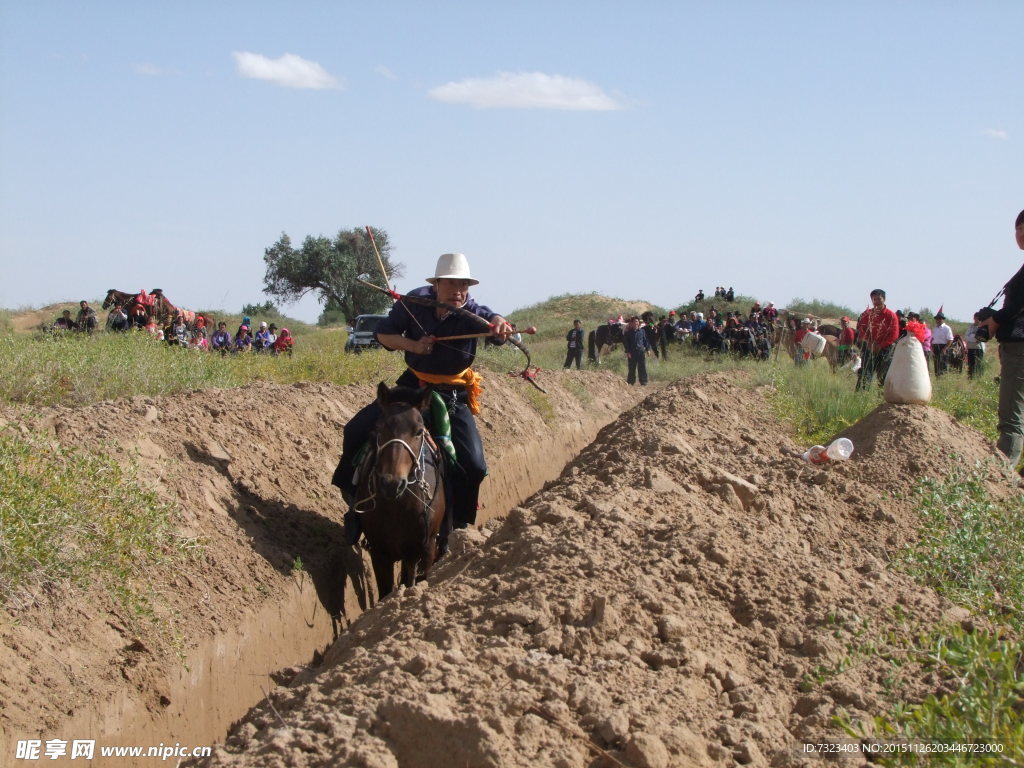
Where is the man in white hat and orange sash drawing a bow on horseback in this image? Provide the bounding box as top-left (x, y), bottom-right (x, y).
top-left (332, 253), bottom-right (514, 551)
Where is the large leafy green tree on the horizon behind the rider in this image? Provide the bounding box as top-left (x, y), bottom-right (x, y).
top-left (263, 227), bottom-right (403, 325)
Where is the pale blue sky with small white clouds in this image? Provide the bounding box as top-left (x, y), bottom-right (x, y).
top-left (0, 0), bottom-right (1024, 323)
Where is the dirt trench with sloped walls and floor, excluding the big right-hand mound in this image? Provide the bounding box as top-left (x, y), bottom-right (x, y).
top-left (0, 372), bottom-right (639, 765)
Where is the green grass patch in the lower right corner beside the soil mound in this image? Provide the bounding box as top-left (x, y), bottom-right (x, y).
top-left (839, 473), bottom-right (1024, 766)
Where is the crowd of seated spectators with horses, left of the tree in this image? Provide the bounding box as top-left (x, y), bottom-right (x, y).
top-left (50, 300), bottom-right (295, 355)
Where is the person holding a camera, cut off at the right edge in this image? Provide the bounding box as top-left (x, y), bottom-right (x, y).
top-left (975, 211), bottom-right (1024, 468)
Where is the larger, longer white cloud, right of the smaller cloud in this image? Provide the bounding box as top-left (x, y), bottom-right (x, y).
top-left (427, 72), bottom-right (621, 112)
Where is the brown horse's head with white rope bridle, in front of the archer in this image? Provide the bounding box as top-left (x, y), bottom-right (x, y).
top-left (375, 382), bottom-right (430, 501)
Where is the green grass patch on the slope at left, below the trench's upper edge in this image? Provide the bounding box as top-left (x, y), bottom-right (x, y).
top-left (0, 428), bottom-right (200, 617)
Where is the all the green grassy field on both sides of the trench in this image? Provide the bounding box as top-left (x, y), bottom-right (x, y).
top-left (0, 295), bottom-right (1024, 766)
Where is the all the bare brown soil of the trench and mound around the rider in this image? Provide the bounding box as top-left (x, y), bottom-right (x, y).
top-left (0, 364), bottom-right (1017, 768)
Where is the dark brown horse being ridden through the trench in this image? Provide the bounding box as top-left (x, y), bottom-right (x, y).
top-left (355, 382), bottom-right (445, 599)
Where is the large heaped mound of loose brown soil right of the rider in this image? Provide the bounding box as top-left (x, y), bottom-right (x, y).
top-left (193, 375), bottom-right (1006, 768)
